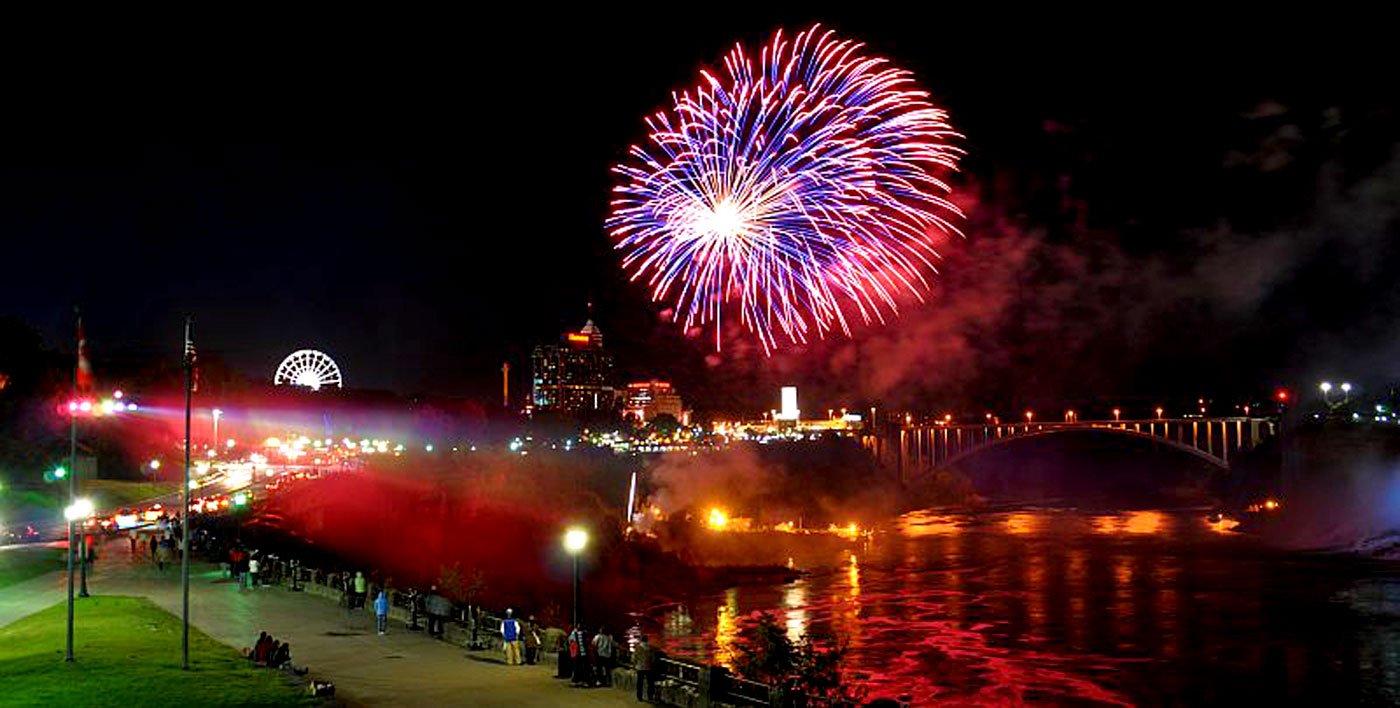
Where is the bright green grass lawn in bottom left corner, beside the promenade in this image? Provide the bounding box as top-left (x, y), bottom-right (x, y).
top-left (0, 596), bottom-right (319, 707)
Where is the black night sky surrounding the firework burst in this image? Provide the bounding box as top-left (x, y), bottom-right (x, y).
top-left (0, 4), bottom-right (1396, 403)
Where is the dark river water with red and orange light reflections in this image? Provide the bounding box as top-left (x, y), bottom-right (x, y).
top-left (648, 509), bottom-right (1400, 705)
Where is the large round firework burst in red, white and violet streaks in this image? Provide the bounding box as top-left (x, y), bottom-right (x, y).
top-left (608, 27), bottom-right (962, 353)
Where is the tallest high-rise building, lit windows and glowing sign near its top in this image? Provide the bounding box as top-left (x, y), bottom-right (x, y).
top-left (531, 320), bottom-right (617, 414)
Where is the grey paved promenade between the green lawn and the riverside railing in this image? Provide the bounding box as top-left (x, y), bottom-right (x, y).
top-left (0, 543), bottom-right (633, 707)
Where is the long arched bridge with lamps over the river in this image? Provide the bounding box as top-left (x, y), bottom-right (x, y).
top-left (861, 417), bottom-right (1278, 481)
